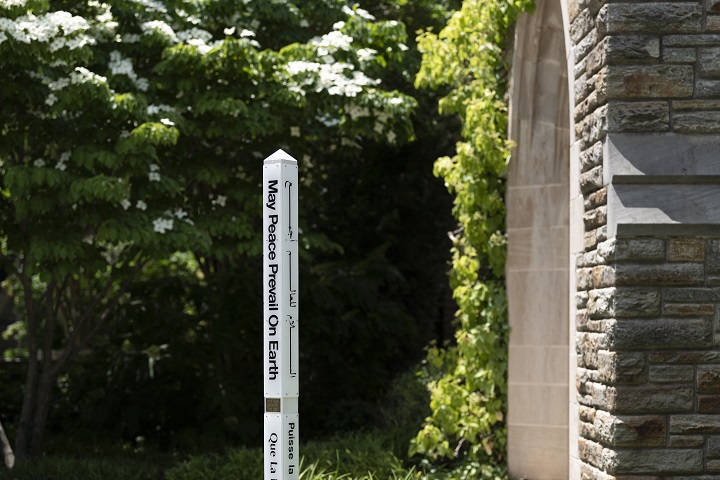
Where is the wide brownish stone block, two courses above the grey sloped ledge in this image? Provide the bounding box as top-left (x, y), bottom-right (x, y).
top-left (605, 64), bottom-right (694, 99)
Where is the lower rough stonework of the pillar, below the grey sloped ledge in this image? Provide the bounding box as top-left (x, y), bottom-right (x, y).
top-left (577, 236), bottom-right (720, 480)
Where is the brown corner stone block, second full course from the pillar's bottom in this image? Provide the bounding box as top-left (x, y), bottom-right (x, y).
top-left (594, 411), bottom-right (666, 447)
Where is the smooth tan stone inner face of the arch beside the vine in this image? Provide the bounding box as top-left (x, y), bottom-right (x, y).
top-left (506, 0), bottom-right (582, 480)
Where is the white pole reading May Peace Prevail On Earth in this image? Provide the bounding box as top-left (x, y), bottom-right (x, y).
top-left (263, 150), bottom-right (300, 480)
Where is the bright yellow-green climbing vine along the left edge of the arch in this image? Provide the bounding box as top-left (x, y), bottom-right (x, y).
top-left (411, 0), bottom-right (533, 462)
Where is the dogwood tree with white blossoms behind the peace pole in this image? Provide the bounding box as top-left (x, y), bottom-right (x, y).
top-left (0, 0), bottom-right (415, 459)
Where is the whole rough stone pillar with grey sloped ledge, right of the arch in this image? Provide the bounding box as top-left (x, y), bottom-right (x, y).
top-left (568, 0), bottom-right (720, 480)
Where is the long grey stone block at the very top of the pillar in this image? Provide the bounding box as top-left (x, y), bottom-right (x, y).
top-left (597, 2), bottom-right (702, 35)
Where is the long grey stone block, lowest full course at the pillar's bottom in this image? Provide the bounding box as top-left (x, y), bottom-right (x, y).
top-left (609, 448), bottom-right (704, 475)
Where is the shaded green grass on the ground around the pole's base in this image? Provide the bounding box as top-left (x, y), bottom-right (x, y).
top-left (0, 375), bottom-right (508, 480)
